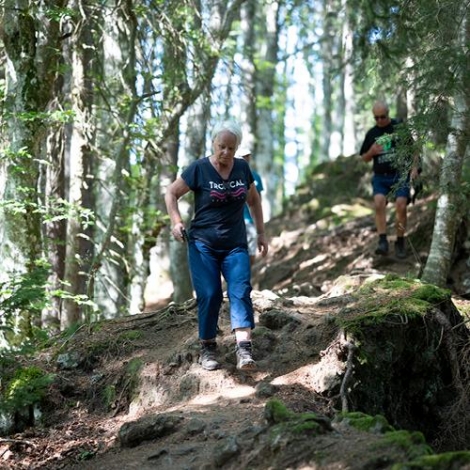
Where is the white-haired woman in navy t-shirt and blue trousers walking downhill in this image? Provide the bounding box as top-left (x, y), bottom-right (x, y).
top-left (165, 121), bottom-right (268, 370)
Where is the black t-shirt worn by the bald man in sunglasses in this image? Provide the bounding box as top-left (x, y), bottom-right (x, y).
top-left (359, 119), bottom-right (412, 175)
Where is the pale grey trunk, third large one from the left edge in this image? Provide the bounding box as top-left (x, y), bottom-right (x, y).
top-left (87, 2), bottom-right (140, 318)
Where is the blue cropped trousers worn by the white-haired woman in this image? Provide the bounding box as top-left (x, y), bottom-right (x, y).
top-left (189, 240), bottom-right (255, 340)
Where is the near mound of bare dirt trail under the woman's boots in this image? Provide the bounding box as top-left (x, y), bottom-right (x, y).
top-left (8, 276), bottom-right (470, 470)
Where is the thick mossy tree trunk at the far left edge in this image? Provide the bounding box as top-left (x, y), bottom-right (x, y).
top-left (3, 0), bottom-right (47, 269)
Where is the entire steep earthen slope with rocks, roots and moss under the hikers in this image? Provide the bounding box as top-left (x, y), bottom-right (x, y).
top-left (0, 155), bottom-right (470, 470)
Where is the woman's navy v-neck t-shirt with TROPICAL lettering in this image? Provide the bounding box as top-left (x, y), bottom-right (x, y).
top-left (181, 157), bottom-right (253, 250)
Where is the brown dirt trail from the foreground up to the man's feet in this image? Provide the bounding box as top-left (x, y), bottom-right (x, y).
top-left (0, 157), bottom-right (470, 470)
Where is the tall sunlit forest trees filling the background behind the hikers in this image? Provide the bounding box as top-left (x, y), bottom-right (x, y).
top-left (0, 0), bottom-right (470, 350)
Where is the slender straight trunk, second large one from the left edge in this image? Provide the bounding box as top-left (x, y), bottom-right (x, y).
top-left (60, 2), bottom-right (95, 329)
